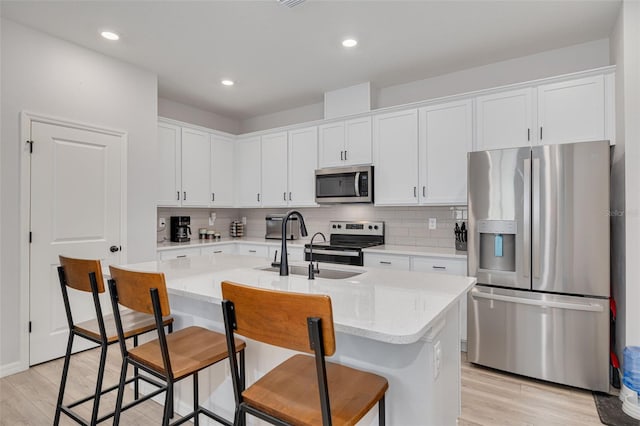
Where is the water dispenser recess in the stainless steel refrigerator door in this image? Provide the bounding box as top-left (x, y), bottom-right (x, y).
top-left (478, 220), bottom-right (516, 272)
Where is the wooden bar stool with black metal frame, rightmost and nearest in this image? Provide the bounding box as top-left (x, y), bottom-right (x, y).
top-left (222, 281), bottom-right (389, 426)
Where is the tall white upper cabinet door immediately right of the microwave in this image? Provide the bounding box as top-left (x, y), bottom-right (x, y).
top-left (373, 109), bottom-right (418, 205)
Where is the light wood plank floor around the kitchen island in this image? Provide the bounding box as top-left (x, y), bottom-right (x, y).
top-left (0, 345), bottom-right (601, 426)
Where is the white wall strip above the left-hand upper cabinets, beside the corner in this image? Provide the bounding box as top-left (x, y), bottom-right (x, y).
top-left (158, 98), bottom-right (240, 135)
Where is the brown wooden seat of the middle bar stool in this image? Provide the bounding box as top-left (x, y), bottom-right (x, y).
top-left (129, 327), bottom-right (245, 381)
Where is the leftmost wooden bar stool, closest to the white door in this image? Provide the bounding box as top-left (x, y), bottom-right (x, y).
top-left (53, 256), bottom-right (173, 425)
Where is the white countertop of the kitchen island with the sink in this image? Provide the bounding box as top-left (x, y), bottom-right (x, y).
top-left (117, 253), bottom-right (476, 344)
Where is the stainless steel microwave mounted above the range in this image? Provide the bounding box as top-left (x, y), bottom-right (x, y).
top-left (316, 166), bottom-right (373, 204)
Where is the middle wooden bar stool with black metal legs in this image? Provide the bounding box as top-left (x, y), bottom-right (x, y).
top-left (109, 266), bottom-right (245, 426)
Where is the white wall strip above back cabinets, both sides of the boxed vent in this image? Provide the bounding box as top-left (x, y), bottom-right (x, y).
top-left (240, 39), bottom-right (610, 133)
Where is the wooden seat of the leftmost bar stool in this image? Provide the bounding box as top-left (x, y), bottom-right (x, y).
top-left (73, 311), bottom-right (173, 344)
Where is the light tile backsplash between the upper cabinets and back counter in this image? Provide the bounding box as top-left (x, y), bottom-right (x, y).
top-left (158, 205), bottom-right (467, 248)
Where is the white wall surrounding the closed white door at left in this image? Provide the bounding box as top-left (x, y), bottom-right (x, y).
top-left (0, 20), bottom-right (157, 373)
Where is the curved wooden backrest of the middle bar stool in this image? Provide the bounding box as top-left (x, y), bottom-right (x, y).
top-left (109, 266), bottom-right (171, 316)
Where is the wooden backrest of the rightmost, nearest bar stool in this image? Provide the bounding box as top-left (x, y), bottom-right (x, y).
top-left (222, 281), bottom-right (336, 356)
